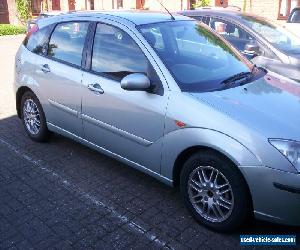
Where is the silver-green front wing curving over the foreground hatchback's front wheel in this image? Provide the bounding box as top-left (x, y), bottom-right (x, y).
top-left (161, 127), bottom-right (261, 214)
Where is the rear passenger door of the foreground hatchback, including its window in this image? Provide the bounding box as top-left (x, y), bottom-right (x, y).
top-left (40, 22), bottom-right (89, 136)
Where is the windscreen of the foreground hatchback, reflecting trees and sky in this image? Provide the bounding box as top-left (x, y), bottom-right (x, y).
top-left (138, 21), bottom-right (252, 92)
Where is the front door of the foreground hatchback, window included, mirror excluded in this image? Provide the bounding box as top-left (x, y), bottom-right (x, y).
top-left (82, 23), bottom-right (168, 173)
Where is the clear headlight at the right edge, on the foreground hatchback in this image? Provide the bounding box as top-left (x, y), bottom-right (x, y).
top-left (269, 139), bottom-right (300, 173)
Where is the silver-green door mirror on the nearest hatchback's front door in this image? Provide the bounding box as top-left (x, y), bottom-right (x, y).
top-left (121, 73), bottom-right (151, 91)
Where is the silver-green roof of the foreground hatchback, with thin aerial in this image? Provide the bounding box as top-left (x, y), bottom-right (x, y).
top-left (41, 10), bottom-right (192, 25)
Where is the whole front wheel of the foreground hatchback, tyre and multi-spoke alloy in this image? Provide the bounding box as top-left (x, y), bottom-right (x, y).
top-left (180, 150), bottom-right (252, 232)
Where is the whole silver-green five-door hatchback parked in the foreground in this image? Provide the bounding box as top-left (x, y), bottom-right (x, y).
top-left (14, 11), bottom-right (300, 231)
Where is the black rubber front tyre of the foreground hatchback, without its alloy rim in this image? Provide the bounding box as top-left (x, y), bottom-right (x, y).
top-left (180, 151), bottom-right (251, 232)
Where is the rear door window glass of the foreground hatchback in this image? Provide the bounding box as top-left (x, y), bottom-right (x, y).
top-left (48, 22), bottom-right (89, 66)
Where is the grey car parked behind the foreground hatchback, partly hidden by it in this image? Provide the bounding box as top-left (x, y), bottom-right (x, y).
top-left (180, 8), bottom-right (300, 83)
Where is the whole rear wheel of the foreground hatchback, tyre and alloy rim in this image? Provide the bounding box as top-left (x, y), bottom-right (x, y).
top-left (21, 91), bottom-right (49, 142)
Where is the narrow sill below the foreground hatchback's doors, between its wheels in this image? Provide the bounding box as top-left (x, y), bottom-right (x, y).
top-left (47, 122), bottom-right (173, 186)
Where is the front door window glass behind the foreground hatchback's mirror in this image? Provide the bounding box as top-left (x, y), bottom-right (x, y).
top-left (91, 24), bottom-right (150, 80)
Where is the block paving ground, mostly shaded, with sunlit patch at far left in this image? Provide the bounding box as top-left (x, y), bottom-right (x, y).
top-left (0, 36), bottom-right (300, 250)
